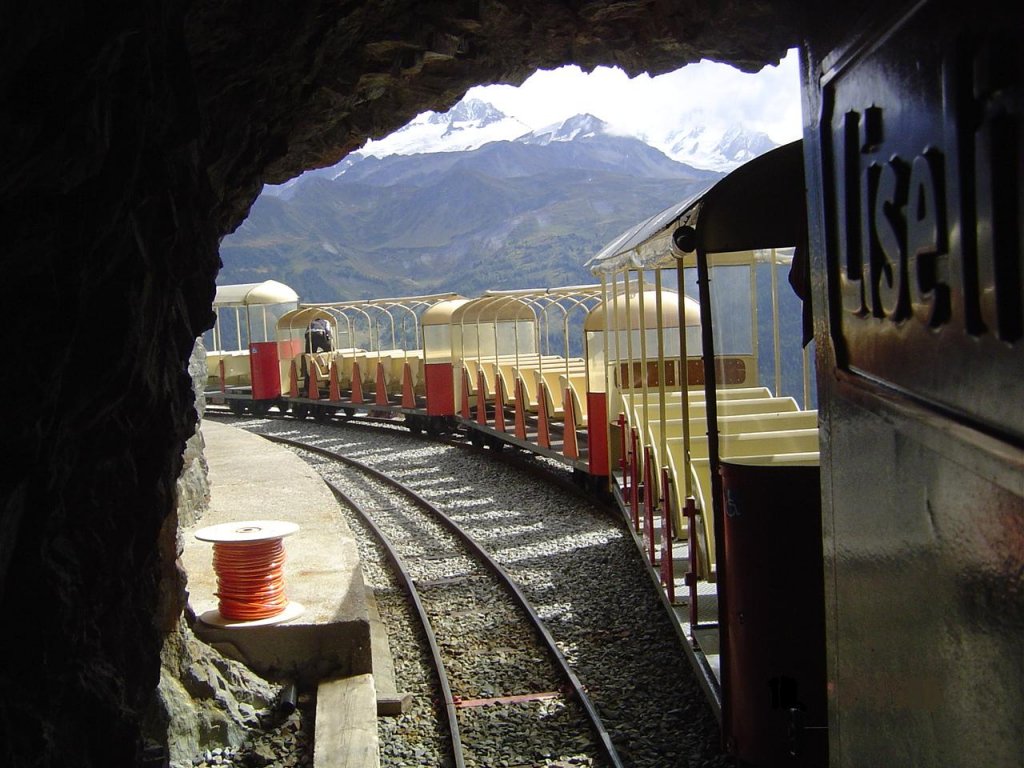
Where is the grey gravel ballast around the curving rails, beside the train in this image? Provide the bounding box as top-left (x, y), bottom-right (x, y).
top-left (211, 416), bottom-right (734, 768)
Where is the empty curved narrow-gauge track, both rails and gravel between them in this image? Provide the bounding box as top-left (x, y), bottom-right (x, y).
top-left (269, 437), bottom-right (623, 768)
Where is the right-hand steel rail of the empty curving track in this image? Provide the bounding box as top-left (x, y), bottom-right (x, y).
top-left (262, 435), bottom-right (624, 768)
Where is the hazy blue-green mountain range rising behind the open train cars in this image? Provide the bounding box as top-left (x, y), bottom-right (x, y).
top-left (219, 104), bottom-right (770, 301)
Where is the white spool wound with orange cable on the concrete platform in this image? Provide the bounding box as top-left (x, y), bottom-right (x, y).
top-left (195, 520), bottom-right (302, 627)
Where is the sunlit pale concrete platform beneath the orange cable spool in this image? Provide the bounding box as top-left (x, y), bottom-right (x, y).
top-left (181, 421), bottom-right (375, 687)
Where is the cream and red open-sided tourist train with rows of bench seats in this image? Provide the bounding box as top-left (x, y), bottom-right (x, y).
top-left (205, 142), bottom-right (827, 765)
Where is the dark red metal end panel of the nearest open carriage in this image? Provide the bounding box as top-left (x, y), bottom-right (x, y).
top-left (720, 462), bottom-right (828, 766)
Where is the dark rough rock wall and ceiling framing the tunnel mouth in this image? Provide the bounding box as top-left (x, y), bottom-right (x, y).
top-left (0, 0), bottom-right (800, 768)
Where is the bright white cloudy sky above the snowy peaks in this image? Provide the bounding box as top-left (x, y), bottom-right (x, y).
top-left (466, 50), bottom-right (801, 144)
